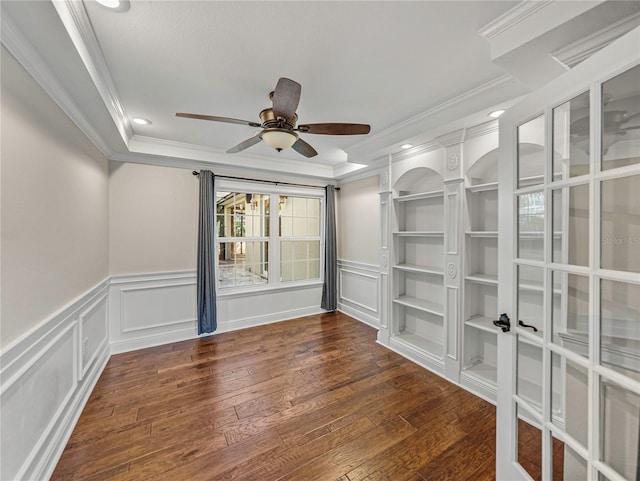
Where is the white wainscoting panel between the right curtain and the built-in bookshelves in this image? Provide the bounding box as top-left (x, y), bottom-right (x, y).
top-left (338, 260), bottom-right (380, 328)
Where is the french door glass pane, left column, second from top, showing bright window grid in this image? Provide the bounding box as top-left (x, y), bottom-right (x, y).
top-left (518, 192), bottom-right (544, 261)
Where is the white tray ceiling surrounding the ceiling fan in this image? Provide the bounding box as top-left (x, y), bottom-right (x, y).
top-left (2, 0), bottom-right (637, 178)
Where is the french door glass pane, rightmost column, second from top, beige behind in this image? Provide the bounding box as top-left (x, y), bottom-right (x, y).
top-left (600, 175), bottom-right (640, 272)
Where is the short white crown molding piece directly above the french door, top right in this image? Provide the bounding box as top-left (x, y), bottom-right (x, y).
top-left (551, 13), bottom-right (640, 68)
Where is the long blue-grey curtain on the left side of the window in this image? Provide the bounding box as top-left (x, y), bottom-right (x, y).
top-left (196, 170), bottom-right (218, 334)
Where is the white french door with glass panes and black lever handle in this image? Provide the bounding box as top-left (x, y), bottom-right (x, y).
top-left (496, 28), bottom-right (640, 481)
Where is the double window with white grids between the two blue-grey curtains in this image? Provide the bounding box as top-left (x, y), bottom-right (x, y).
top-left (215, 181), bottom-right (324, 289)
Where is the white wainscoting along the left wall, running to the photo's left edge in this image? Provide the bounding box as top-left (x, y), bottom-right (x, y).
top-left (0, 280), bottom-right (109, 480)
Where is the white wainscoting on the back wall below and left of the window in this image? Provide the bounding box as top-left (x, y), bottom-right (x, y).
top-left (109, 271), bottom-right (323, 354)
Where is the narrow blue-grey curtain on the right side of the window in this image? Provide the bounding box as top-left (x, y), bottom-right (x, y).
top-left (320, 185), bottom-right (338, 311)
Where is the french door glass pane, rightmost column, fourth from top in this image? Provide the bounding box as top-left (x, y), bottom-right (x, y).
top-left (600, 380), bottom-right (640, 479)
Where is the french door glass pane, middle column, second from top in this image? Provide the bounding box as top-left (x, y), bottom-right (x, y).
top-left (552, 184), bottom-right (589, 266)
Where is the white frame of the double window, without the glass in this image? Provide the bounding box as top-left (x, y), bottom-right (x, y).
top-left (214, 178), bottom-right (326, 297)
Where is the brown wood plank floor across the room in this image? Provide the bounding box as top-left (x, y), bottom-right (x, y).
top-left (52, 313), bottom-right (495, 481)
